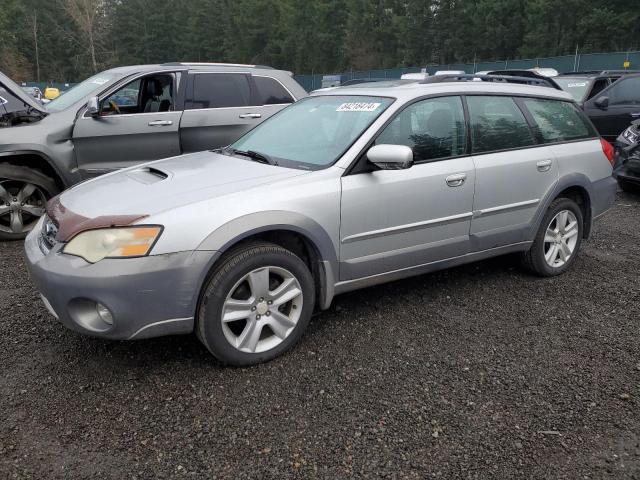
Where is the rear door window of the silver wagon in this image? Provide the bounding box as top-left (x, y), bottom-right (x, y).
top-left (467, 96), bottom-right (535, 153)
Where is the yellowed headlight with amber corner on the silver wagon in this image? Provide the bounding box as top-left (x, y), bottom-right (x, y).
top-left (62, 226), bottom-right (162, 263)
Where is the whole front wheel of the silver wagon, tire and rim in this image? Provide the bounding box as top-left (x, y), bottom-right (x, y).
top-left (196, 242), bottom-right (315, 367)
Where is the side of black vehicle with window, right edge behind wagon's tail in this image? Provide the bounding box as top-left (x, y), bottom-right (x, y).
top-left (584, 75), bottom-right (640, 142)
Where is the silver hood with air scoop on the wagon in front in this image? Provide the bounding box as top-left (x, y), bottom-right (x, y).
top-left (55, 152), bottom-right (309, 223)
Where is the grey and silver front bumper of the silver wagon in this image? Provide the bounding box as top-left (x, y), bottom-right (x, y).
top-left (25, 227), bottom-right (218, 340)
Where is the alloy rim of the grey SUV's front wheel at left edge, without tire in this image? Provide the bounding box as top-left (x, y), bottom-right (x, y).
top-left (0, 180), bottom-right (47, 234)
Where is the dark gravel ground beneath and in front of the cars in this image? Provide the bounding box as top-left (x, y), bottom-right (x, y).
top-left (0, 195), bottom-right (640, 479)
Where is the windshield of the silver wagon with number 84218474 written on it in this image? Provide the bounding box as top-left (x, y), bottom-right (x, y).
top-left (231, 95), bottom-right (393, 169)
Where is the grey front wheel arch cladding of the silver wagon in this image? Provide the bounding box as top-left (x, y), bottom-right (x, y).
top-left (198, 211), bottom-right (338, 308)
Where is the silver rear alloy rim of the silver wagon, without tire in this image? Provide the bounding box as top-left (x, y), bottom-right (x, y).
top-left (544, 210), bottom-right (580, 268)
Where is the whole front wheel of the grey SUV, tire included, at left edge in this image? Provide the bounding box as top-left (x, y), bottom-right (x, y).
top-left (0, 163), bottom-right (59, 241)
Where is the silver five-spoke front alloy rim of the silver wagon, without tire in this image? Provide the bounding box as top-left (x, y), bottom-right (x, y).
top-left (221, 266), bottom-right (303, 353)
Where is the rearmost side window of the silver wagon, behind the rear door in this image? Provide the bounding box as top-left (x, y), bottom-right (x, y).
top-left (524, 99), bottom-right (593, 143)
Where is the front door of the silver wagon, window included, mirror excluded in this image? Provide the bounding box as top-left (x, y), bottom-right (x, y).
top-left (340, 97), bottom-right (475, 280)
